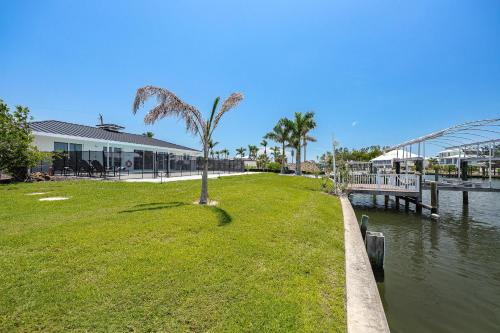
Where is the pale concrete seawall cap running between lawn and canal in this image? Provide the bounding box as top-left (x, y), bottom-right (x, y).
top-left (340, 197), bottom-right (389, 333)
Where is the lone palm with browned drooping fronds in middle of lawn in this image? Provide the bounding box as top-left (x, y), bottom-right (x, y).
top-left (132, 86), bottom-right (243, 205)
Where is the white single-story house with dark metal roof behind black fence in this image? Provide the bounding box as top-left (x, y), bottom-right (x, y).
top-left (30, 120), bottom-right (202, 170)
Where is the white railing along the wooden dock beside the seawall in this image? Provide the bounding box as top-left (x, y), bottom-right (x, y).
top-left (346, 173), bottom-right (420, 192)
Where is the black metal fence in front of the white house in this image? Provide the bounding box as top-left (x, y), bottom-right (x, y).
top-left (31, 151), bottom-right (244, 179)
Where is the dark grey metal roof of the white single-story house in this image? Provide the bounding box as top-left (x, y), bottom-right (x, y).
top-left (30, 120), bottom-right (199, 152)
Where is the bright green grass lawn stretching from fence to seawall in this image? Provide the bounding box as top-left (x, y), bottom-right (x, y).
top-left (0, 174), bottom-right (346, 332)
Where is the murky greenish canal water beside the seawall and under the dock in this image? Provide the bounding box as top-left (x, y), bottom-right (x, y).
top-left (351, 180), bottom-right (500, 333)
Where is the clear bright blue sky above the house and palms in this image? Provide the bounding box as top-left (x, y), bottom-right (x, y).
top-left (0, 0), bottom-right (500, 158)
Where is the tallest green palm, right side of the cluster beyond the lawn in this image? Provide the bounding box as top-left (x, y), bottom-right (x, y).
top-left (285, 112), bottom-right (316, 176)
